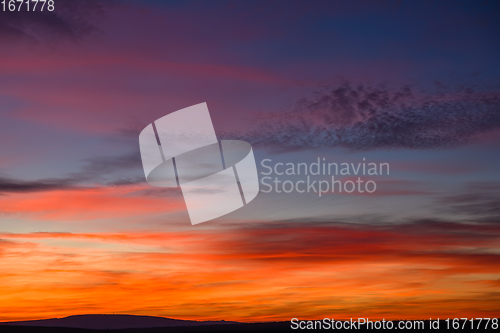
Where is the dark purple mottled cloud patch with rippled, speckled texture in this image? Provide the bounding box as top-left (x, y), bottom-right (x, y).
top-left (226, 82), bottom-right (500, 150)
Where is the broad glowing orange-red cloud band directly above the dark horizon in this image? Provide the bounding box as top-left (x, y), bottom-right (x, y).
top-left (0, 221), bottom-right (500, 321)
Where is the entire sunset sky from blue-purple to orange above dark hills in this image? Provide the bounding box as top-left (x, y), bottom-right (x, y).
top-left (0, 0), bottom-right (500, 322)
